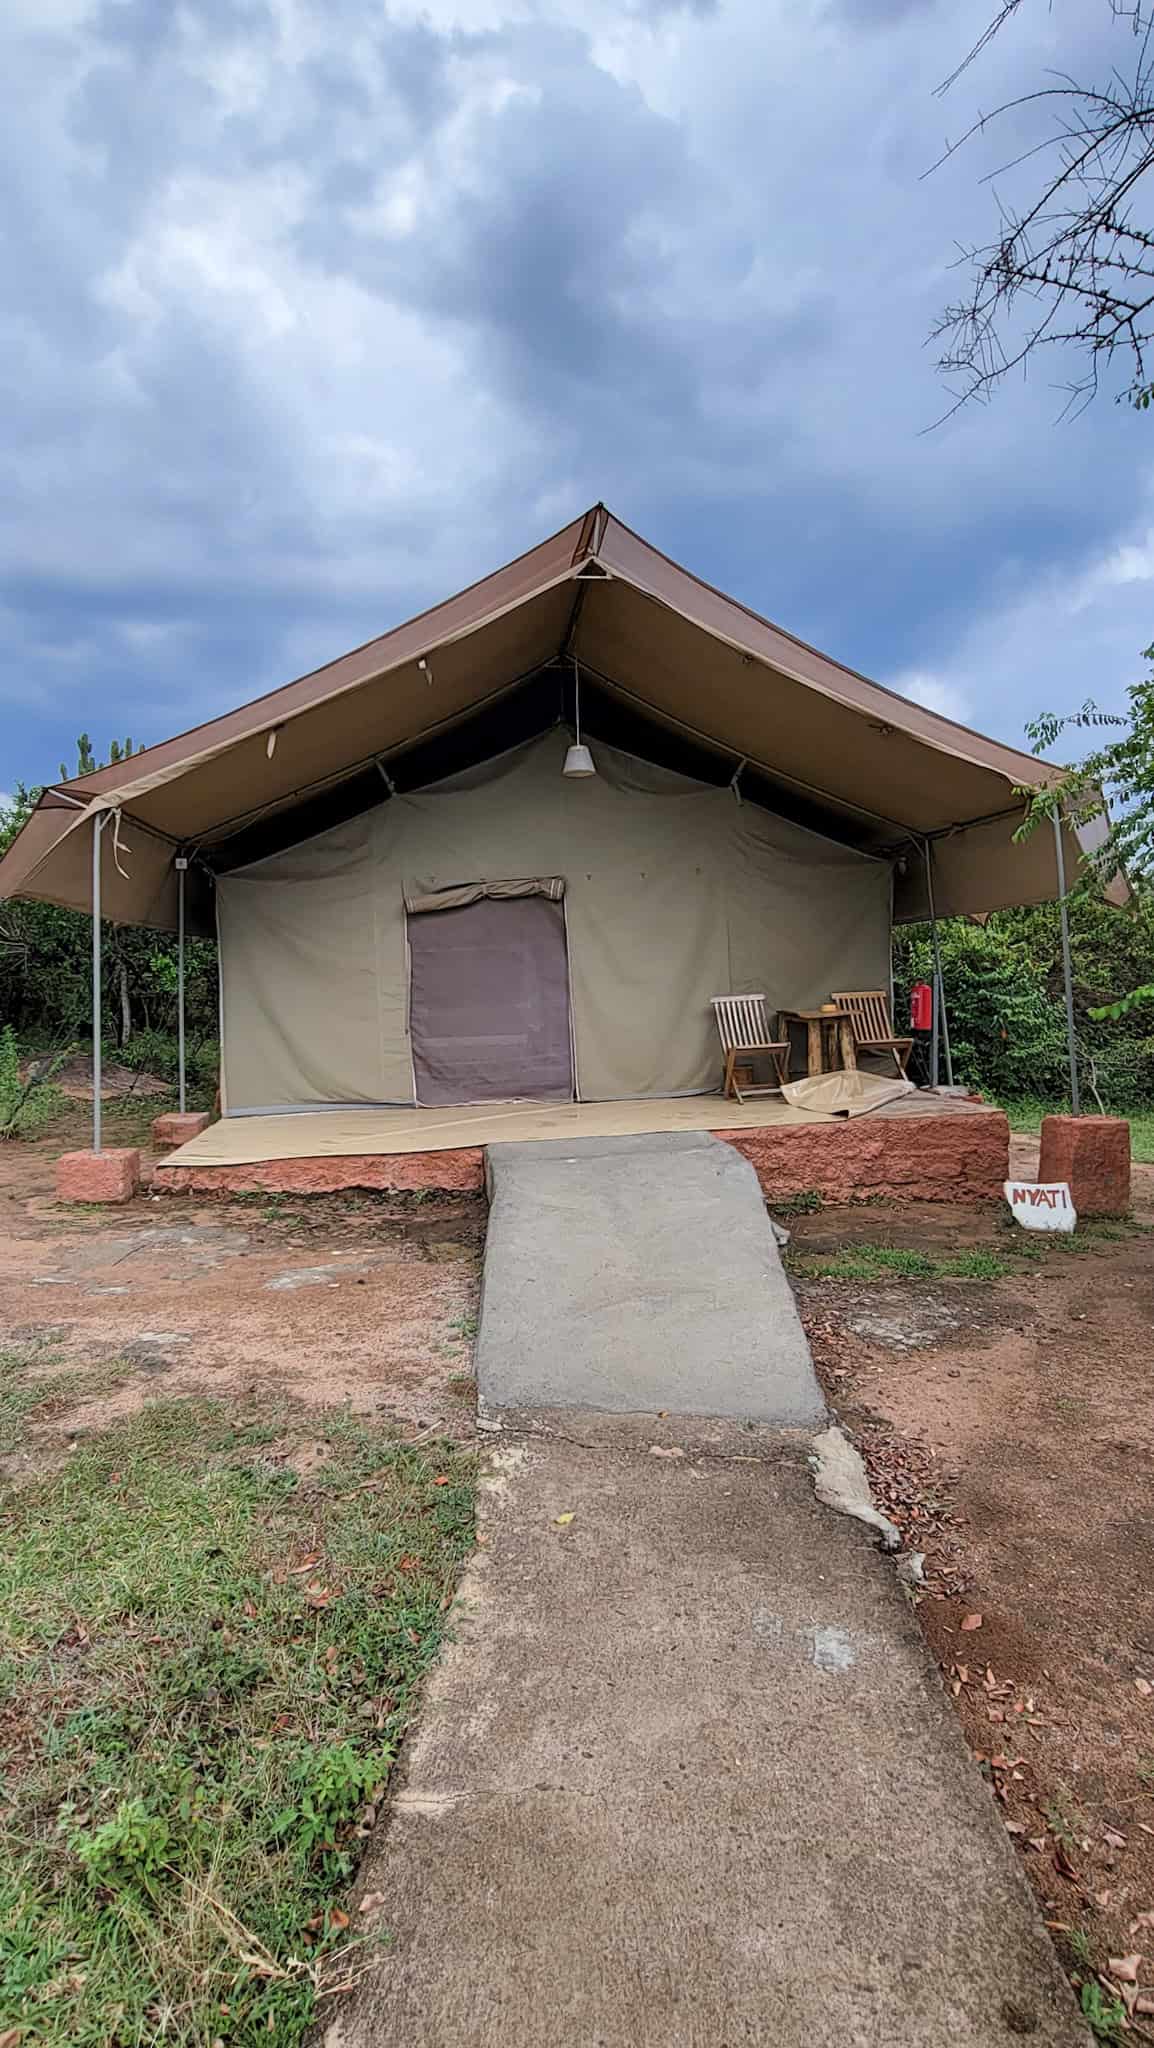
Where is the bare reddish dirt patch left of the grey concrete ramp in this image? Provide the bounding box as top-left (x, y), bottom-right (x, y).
top-left (0, 1104), bottom-right (486, 1475)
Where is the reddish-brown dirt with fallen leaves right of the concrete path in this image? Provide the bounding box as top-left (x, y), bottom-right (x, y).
top-left (787, 1139), bottom-right (1154, 2015)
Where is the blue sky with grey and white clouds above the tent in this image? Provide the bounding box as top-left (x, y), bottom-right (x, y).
top-left (0, 0), bottom-right (1154, 788)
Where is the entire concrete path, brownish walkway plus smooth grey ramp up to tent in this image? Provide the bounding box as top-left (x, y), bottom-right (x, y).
top-left (326, 1137), bottom-right (1086, 2048)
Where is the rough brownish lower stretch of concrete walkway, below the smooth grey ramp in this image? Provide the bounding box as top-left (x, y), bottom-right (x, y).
top-left (326, 1413), bottom-right (1086, 2048)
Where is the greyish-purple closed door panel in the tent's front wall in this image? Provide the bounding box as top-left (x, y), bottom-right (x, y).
top-left (408, 897), bottom-right (574, 1108)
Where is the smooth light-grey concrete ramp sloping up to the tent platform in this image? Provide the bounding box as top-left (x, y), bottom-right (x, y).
top-left (476, 1130), bottom-right (824, 1425)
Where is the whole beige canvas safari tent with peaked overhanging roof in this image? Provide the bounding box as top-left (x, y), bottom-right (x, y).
top-left (0, 506), bottom-right (1090, 1110)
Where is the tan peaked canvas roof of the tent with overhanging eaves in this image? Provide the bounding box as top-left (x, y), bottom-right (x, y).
top-left (0, 506), bottom-right (1123, 930)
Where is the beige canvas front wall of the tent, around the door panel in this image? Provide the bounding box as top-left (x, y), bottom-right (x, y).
top-left (219, 733), bottom-right (890, 1114)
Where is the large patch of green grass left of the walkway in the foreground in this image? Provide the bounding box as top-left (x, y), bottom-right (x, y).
top-left (0, 1382), bottom-right (473, 2048)
